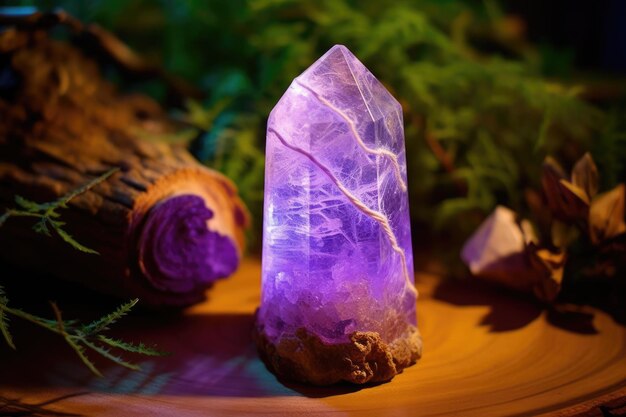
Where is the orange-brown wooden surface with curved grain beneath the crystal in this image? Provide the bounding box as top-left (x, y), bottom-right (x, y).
top-left (0, 260), bottom-right (626, 416)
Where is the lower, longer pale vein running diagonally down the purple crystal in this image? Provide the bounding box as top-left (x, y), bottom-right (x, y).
top-left (268, 127), bottom-right (417, 295)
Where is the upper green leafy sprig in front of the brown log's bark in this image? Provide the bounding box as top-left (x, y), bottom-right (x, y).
top-left (0, 168), bottom-right (119, 254)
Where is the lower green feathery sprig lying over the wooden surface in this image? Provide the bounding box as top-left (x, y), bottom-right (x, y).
top-left (0, 287), bottom-right (167, 376)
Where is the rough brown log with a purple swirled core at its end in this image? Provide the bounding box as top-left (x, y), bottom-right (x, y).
top-left (0, 29), bottom-right (248, 305)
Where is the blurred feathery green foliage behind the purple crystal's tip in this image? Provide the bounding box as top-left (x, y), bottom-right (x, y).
top-left (17, 0), bottom-right (626, 252)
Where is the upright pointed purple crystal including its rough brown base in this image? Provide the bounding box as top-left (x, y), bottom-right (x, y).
top-left (257, 45), bottom-right (421, 384)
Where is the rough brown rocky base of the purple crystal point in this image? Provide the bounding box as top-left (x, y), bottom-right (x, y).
top-left (255, 326), bottom-right (422, 385)
